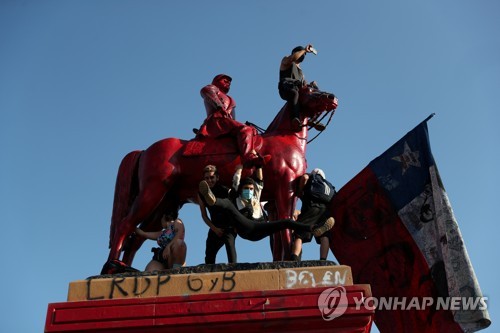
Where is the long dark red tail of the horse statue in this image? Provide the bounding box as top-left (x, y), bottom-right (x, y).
top-left (109, 150), bottom-right (142, 248)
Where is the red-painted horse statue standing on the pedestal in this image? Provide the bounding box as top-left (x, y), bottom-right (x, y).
top-left (109, 87), bottom-right (337, 265)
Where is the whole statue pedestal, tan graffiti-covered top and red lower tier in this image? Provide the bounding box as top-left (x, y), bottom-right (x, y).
top-left (45, 261), bottom-right (374, 333)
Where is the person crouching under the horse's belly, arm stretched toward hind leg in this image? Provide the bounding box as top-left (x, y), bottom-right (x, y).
top-left (135, 212), bottom-right (187, 272)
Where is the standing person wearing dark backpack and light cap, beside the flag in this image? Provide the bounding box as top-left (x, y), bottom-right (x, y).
top-left (290, 168), bottom-right (335, 261)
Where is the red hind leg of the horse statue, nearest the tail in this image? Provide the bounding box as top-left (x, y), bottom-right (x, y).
top-left (108, 181), bottom-right (166, 260)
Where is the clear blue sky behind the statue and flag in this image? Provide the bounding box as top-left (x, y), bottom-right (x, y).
top-left (0, 0), bottom-right (500, 333)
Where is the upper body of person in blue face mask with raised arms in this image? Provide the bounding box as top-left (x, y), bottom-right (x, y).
top-left (233, 165), bottom-right (265, 222)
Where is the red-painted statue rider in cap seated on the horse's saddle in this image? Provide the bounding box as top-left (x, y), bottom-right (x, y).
top-left (197, 74), bottom-right (262, 165)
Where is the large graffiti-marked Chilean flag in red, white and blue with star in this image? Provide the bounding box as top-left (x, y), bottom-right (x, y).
top-left (331, 119), bottom-right (491, 333)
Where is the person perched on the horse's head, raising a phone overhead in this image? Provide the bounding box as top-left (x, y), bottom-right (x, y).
top-left (278, 44), bottom-right (314, 131)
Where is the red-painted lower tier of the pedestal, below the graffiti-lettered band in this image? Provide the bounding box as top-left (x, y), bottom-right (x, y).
top-left (45, 285), bottom-right (374, 333)
